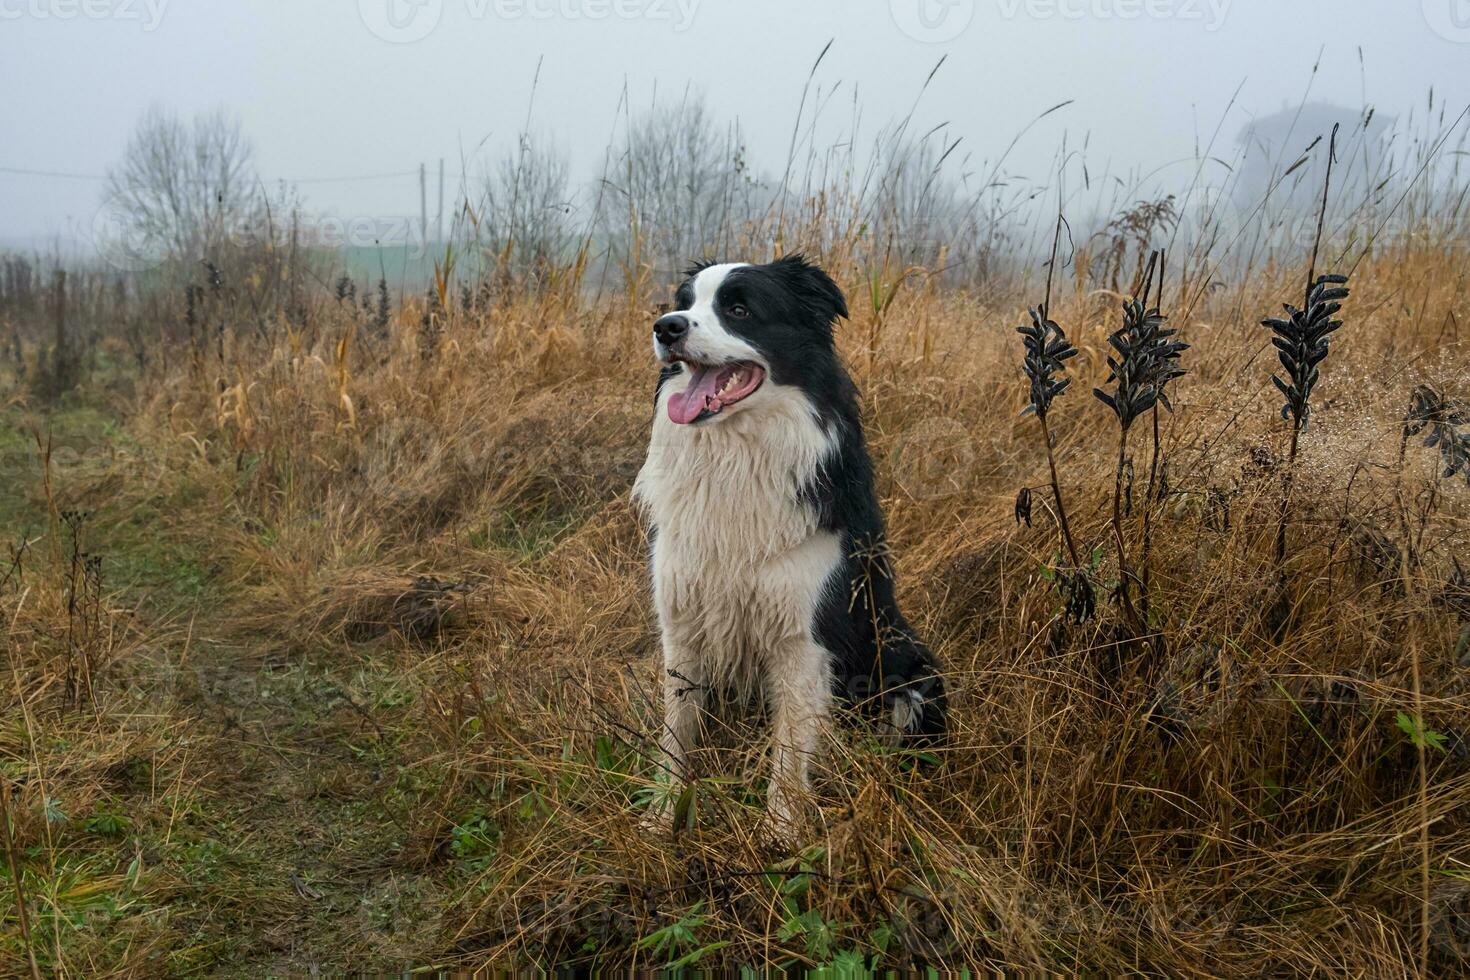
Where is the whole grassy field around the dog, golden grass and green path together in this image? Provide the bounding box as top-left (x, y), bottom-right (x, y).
top-left (0, 220), bottom-right (1470, 977)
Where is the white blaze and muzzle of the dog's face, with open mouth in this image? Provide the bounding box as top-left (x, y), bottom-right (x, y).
top-left (653, 263), bottom-right (770, 425)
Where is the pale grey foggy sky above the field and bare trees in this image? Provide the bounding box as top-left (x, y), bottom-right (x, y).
top-left (0, 0), bottom-right (1470, 245)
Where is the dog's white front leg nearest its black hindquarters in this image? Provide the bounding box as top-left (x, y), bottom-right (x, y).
top-left (766, 639), bottom-right (832, 840)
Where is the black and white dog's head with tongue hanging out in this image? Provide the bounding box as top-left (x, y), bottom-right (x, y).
top-left (653, 254), bottom-right (847, 425)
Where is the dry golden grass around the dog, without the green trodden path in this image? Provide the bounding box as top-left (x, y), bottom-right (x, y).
top-left (0, 235), bottom-right (1470, 977)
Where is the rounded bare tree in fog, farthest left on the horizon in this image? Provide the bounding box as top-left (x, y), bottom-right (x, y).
top-left (107, 106), bottom-right (256, 268)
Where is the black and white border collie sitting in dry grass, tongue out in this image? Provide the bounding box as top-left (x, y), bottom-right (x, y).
top-left (634, 256), bottom-right (945, 832)
